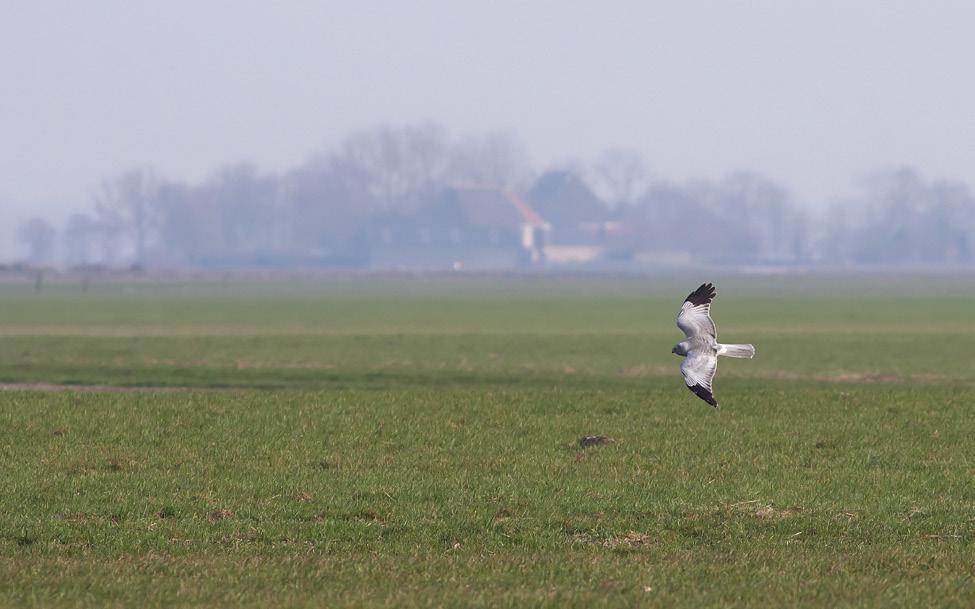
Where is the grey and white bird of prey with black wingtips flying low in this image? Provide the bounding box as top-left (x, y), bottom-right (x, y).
top-left (671, 283), bottom-right (755, 407)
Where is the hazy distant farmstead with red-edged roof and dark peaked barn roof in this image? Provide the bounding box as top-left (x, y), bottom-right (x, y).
top-left (358, 171), bottom-right (656, 270)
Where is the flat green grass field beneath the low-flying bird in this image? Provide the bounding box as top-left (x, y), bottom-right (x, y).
top-left (0, 275), bottom-right (975, 608)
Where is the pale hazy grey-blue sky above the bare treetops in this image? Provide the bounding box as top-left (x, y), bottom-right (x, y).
top-left (0, 0), bottom-right (975, 247)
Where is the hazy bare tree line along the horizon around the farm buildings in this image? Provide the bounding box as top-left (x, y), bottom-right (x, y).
top-left (18, 123), bottom-right (975, 268)
